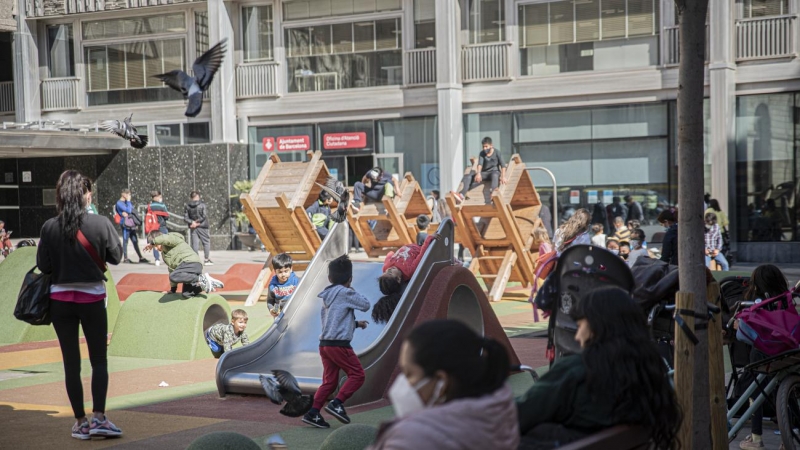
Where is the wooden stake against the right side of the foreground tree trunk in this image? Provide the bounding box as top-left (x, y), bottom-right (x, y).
top-left (706, 281), bottom-right (728, 450)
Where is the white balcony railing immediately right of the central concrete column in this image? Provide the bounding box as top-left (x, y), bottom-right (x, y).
top-left (461, 42), bottom-right (511, 83)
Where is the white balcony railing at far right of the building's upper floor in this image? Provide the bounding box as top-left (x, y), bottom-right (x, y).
top-left (736, 15), bottom-right (797, 61)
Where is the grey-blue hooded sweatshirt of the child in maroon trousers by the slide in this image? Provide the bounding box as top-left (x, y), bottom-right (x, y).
top-left (318, 284), bottom-right (370, 347)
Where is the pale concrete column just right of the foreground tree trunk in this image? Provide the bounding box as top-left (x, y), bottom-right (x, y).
top-left (708, 0), bottom-right (736, 239)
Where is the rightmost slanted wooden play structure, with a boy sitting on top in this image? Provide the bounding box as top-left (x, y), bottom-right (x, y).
top-left (445, 155), bottom-right (543, 301)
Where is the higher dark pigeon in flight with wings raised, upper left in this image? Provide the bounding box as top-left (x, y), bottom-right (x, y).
top-left (153, 39), bottom-right (227, 117)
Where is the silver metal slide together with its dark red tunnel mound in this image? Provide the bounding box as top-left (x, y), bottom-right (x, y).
top-left (217, 220), bottom-right (519, 405)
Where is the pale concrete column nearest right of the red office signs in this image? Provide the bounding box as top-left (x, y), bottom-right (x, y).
top-left (436, 0), bottom-right (465, 194)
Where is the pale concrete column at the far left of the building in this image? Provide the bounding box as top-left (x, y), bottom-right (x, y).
top-left (14, 0), bottom-right (42, 122)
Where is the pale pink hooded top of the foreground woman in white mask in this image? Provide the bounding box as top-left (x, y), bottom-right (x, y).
top-left (368, 385), bottom-right (520, 450)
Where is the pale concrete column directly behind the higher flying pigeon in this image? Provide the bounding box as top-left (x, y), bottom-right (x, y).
top-left (208, 0), bottom-right (238, 143)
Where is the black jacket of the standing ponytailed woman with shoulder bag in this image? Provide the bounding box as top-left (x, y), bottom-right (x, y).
top-left (36, 213), bottom-right (122, 284)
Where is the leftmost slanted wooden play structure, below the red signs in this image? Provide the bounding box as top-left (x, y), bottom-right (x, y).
top-left (240, 151), bottom-right (330, 305)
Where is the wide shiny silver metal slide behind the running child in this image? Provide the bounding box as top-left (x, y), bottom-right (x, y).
top-left (217, 219), bottom-right (454, 404)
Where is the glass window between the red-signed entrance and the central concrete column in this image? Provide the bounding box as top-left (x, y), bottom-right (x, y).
top-left (378, 116), bottom-right (439, 193)
